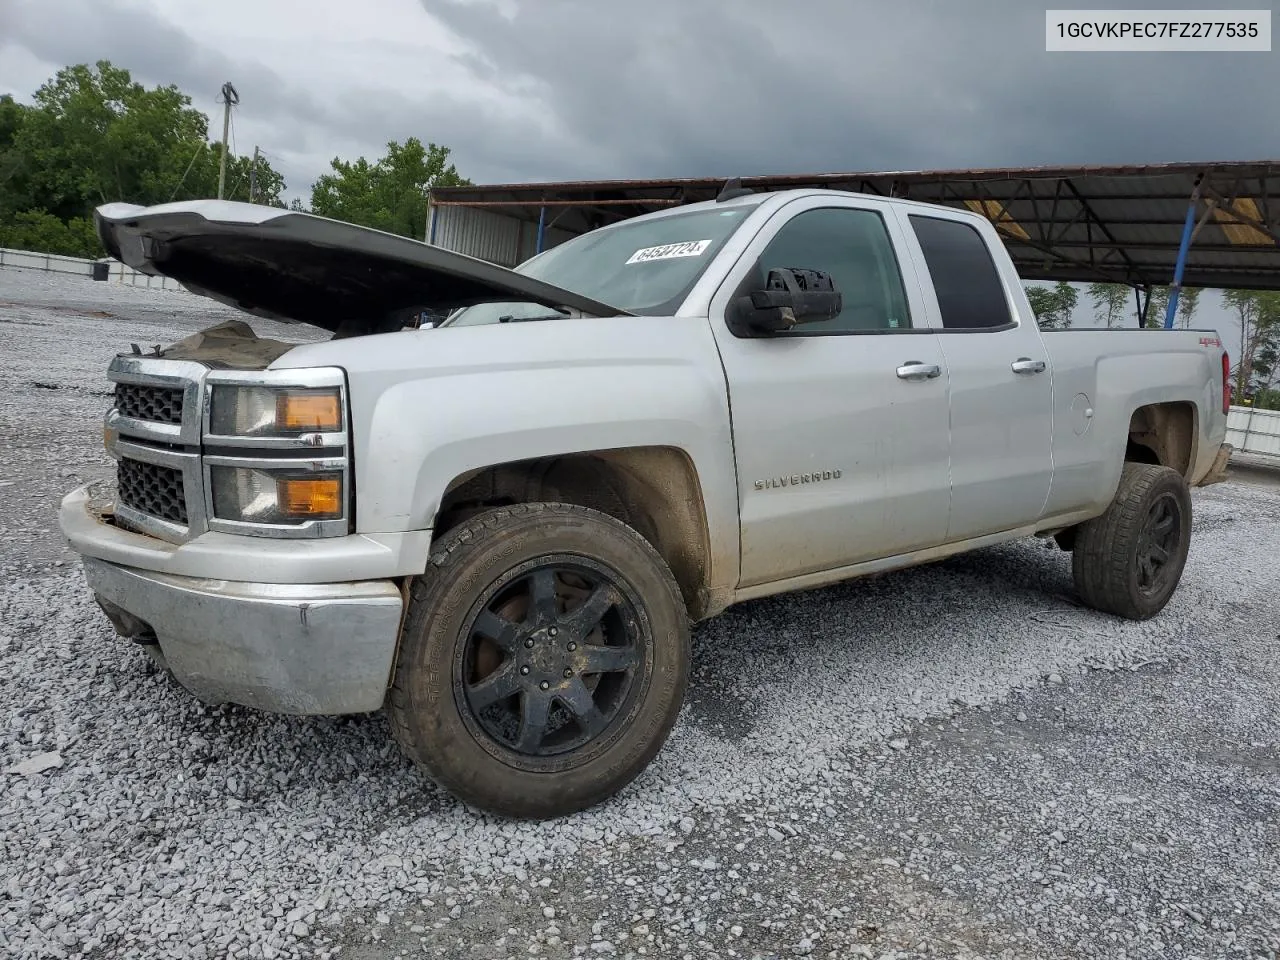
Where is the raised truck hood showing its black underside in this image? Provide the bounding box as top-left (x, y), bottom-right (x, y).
top-left (93, 200), bottom-right (627, 335)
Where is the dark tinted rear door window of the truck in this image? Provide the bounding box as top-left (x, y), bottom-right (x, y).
top-left (910, 214), bottom-right (1014, 330)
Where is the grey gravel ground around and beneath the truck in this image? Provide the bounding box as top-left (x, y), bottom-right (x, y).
top-left (0, 271), bottom-right (1280, 960)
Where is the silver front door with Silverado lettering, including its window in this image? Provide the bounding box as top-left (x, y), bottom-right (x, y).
top-left (710, 197), bottom-right (950, 588)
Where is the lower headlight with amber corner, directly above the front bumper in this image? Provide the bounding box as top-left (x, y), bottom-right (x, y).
top-left (209, 466), bottom-right (346, 525)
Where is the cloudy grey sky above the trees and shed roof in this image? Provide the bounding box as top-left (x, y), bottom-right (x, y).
top-left (0, 0), bottom-right (1280, 345)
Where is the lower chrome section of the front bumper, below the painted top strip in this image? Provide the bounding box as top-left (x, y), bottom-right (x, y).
top-left (84, 557), bottom-right (402, 714)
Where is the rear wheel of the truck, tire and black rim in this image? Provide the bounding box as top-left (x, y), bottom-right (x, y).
top-left (1071, 463), bottom-right (1192, 620)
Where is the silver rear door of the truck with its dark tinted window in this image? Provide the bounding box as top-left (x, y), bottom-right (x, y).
top-left (902, 209), bottom-right (1053, 541)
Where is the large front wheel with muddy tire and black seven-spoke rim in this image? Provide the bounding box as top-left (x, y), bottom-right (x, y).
top-left (389, 503), bottom-right (689, 818)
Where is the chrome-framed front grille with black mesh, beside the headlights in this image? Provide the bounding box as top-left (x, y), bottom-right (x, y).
top-left (106, 356), bottom-right (209, 543)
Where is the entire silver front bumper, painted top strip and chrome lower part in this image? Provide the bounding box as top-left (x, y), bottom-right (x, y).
top-left (59, 488), bottom-right (409, 714)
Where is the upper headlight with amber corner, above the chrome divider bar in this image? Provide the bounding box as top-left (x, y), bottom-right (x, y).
top-left (209, 385), bottom-right (343, 436)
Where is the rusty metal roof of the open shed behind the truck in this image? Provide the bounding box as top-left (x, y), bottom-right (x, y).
top-left (431, 160), bottom-right (1280, 289)
